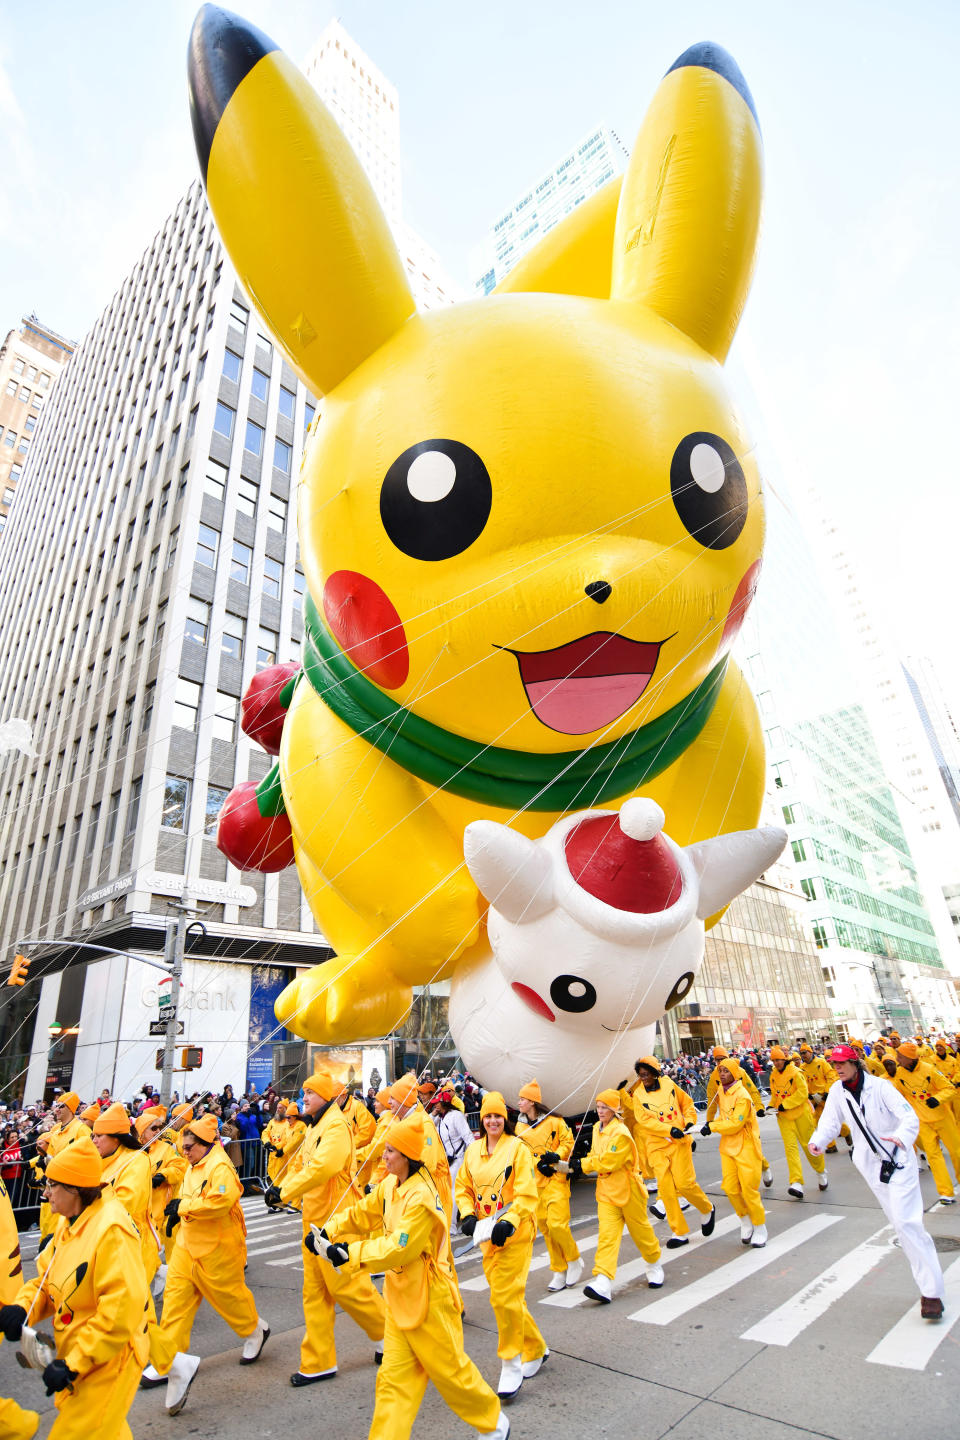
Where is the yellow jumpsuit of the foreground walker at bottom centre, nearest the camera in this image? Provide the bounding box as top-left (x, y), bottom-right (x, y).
top-left (327, 1171), bottom-right (499, 1440)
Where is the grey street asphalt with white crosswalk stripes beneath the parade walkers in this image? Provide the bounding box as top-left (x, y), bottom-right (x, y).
top-left (0, 1117), bottom-right (960, 1440)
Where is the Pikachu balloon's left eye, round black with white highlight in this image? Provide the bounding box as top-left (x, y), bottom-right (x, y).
top-left (380, 441), bottom-right (494, 560)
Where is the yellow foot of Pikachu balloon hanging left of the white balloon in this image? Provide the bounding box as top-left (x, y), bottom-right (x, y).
top-left (275, 955), bottom-right (413, 1045)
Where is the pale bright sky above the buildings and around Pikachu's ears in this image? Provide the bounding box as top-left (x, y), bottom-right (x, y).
top-left (0, 0), bottom-right (960, 714)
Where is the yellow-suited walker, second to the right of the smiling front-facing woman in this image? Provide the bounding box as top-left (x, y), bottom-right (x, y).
top-left (573, 1090), bottom-right (664, 1305)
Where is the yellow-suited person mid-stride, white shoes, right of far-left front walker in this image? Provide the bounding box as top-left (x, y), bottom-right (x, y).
top-left (141, 1115), bottom-right (271, 1416)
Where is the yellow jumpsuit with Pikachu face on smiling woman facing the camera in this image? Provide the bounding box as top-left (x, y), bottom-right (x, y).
top-left (456, 1133), bottom-right (547, 1361)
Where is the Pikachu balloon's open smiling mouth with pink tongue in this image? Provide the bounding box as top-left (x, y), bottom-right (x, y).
top-left (504, 631), bottom-right (664, 734)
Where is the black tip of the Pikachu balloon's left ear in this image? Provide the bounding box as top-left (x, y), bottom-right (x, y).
top-left (187, 4), bottom-right (278, 181)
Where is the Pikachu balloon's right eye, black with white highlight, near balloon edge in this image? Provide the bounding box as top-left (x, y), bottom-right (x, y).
top-left (671, 431), bottom-right (747, 550)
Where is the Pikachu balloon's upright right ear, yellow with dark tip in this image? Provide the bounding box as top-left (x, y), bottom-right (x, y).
top-left (610, 43), bottom-right (763, 363)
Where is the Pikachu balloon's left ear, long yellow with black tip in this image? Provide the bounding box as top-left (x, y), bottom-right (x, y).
top-left (187, 4), bottom-right (416, 395)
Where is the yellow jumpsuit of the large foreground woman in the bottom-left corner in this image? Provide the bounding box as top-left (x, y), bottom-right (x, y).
top-left (14, 1191), bottom-right (150, 1440)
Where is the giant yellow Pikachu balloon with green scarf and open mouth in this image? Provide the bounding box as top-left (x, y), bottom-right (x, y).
top-left (189, 6), bottom-right (764, 1043)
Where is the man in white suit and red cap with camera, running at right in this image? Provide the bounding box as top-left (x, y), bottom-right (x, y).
top-left (807, 1045), bottom-right (944, 1320)
